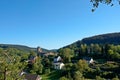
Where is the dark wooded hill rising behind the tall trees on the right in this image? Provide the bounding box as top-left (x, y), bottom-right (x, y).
top-left (66, 32), bottom-right (120, 47)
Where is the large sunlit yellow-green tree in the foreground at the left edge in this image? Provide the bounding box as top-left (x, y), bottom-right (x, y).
top-left (0, 48), bottom-right (26, 80)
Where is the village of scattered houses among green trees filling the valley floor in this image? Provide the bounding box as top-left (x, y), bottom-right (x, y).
top-left (0, 44), bottom-right (120, 80)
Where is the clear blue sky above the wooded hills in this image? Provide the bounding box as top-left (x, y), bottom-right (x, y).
top-left (0, 0), bottom-right (120, 49)
